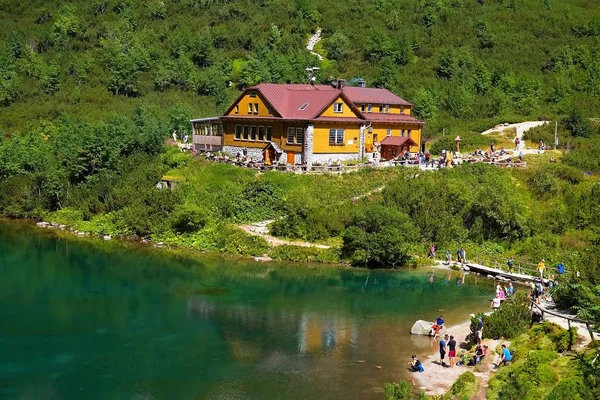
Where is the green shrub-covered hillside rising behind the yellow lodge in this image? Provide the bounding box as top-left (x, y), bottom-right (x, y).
top-left (0, 0), bottom-right (600, 137)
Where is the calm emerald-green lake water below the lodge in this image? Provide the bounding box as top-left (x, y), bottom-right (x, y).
top-left (0, 222), bottom-right (492, 400)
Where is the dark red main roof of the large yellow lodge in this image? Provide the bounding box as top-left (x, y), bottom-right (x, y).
top-left (225, 83), bottom-right (418, 122)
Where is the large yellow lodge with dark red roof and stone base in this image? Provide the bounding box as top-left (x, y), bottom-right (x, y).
top-left (191, 80), bottom-right (424, 167)
